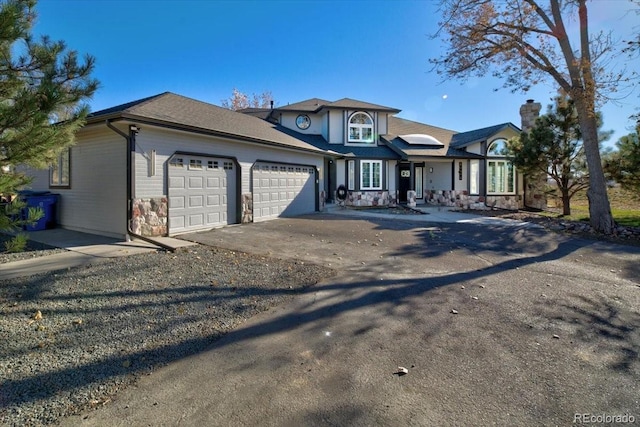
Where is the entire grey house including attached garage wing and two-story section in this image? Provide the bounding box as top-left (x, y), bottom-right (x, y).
top-left (21, 92), bottom-right (539, 242)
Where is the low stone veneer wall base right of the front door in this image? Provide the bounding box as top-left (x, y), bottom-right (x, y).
top-left (424, 190), bottom-right (524, 210)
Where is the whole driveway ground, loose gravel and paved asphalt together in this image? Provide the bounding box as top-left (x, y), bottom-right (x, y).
top-left (0, 214), bottom-right (640, 426)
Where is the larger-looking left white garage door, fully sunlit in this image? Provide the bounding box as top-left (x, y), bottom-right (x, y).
top-left (169, 155), bottom-right (237, 234)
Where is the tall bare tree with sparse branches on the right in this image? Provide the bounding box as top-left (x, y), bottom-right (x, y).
top-left (431, 0), bottom-right (637, 234)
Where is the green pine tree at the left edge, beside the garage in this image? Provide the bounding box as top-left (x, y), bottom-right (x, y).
top-left (0, 0), bottom-right (98, 249)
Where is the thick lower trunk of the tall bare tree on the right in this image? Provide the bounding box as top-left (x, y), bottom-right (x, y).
top-left (574, 98), bottom-right (615, 234)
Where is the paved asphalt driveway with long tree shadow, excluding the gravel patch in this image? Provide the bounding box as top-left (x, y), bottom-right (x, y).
top-left (65, 214), bottom-right (640, 426)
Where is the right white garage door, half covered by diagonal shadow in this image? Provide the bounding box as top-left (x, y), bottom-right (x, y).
top-left (251, 162), bottom-right (316, 222)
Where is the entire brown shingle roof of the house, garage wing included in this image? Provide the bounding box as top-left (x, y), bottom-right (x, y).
top-left (87, 92), bottom-right (519, 159)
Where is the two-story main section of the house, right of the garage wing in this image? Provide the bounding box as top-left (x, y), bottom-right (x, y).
top-left (258, 98), bottom-right (540, 214)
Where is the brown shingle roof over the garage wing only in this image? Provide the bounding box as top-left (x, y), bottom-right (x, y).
top-left (87, 92), bottom-right (320, 152)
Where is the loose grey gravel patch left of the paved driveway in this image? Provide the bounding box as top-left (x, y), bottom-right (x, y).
top-left (0, 242), bottom-right (335, 426)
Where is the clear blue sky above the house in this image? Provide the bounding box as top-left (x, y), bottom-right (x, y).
top-left (34, 0), bottom-right (640, 145)
